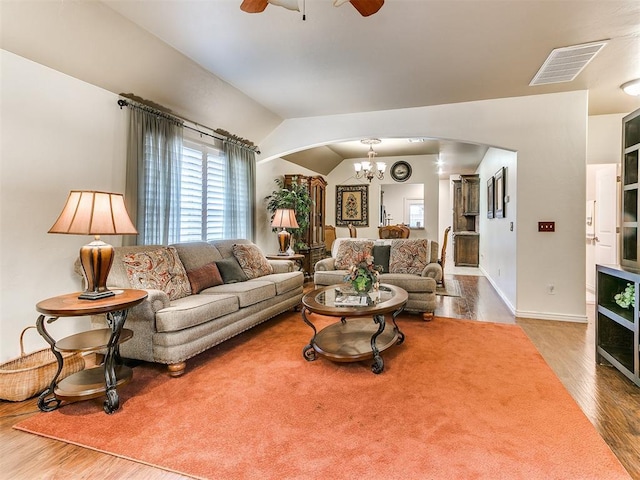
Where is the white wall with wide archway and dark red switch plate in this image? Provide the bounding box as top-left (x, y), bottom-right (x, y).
top-left (261, 91), bottom-right (588, 321)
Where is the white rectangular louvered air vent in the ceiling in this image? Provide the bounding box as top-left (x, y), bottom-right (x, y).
top-left (529, 41), bottom-right (607, 87)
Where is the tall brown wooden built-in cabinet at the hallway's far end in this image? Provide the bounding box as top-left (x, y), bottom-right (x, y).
top-left (453, 175), bottom-right (480, 267)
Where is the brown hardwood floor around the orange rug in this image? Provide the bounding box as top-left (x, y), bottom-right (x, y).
top-left (0, 275), bottom-right (640, 480)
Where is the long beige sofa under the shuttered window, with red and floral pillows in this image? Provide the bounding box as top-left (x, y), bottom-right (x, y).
top-left (86, 239), bottom-right (304, 376)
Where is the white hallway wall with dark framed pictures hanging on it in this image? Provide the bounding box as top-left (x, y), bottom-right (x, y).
top-left (476, 148), bottom-right (520, 311)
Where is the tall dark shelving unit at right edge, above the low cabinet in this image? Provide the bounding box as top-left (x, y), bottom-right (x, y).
top-left (620, 110), bottom-right (640, 269)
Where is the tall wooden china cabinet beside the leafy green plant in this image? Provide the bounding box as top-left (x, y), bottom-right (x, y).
top-left (284, 174), bottom-right (327, 276)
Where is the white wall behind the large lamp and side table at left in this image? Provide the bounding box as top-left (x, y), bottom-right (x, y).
top-left (0, 50), bottom-right (127, 360)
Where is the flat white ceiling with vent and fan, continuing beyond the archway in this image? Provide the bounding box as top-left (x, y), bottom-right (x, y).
top-left (103, 0), bottom-right (640, 174)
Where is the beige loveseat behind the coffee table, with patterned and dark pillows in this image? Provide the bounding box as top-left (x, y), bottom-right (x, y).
top-left (313, 238), bottom-right (442, 320)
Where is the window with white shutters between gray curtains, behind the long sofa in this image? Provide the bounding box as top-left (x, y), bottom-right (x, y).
top-left (178, 139), bottom-right (227, 242)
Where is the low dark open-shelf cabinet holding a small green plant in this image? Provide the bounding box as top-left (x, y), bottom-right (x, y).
top-left (596, 265), bottom-right (640, 386)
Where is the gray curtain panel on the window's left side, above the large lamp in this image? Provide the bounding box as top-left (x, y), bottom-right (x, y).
top-left (125, 103), bottom-right (183, 245)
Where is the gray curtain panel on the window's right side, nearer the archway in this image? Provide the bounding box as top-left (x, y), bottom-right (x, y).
top-left (223, 141), bottom-right (256, 241)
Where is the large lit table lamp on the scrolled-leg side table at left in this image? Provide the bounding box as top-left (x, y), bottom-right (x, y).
top-left (49, 190), bottom-right (138, 300)
